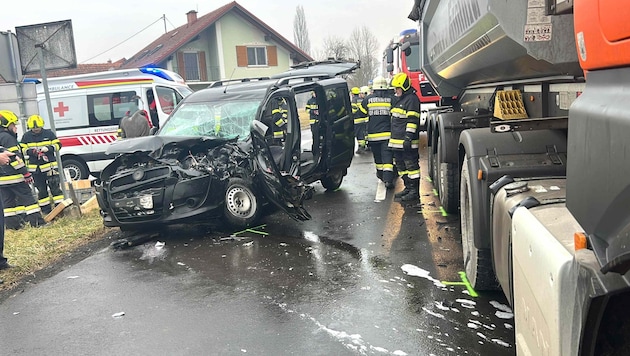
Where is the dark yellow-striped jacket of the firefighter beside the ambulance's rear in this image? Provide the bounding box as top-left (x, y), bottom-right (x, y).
top-left (21, 129), bottom-right (61, 173)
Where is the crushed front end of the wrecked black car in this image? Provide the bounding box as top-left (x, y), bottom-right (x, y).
top-left (96, 136), bottom-right (251, 228)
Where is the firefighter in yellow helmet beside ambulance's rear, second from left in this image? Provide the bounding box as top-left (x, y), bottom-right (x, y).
top-left (21, 115), bottom-right (63, 214)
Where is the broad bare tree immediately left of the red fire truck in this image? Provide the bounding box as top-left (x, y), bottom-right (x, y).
top-left (348, 26), bottom-right (379, 87)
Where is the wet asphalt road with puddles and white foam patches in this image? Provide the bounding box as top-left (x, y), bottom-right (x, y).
top-left (0, 139), bottom-right (514, 356)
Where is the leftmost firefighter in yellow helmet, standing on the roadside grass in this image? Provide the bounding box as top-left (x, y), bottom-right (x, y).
top-left (0, 110), bottom-right (46, 230)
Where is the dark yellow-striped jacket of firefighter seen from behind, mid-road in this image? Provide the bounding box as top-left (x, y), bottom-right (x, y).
top-left (359, 90), bottom-right (392, 141)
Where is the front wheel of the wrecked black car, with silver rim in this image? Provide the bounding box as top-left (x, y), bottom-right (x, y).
top-left (224, 178), bottom-right (262, 227)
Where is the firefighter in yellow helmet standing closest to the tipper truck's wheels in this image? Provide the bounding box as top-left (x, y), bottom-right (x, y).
top-left (388, 73), bottom-right (420, 203)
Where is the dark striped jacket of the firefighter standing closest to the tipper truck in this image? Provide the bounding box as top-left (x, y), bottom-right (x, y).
top-left (388, 89), bottom-right (420, 150)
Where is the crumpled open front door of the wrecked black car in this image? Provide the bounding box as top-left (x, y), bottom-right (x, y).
top-left (251, 103), bottom-right (313, 221)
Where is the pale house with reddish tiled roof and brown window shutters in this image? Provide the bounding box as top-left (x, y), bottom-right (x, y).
top-left (120, 1), bottom-right (313, 89)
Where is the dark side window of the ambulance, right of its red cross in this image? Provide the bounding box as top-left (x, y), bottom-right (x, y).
top-left (88, 91), bottom-right (139, 126)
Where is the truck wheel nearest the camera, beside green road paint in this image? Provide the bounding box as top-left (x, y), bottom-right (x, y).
top-left (460, 156), bottom-right (499, 290)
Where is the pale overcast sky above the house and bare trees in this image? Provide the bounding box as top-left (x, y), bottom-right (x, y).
top-left (0, 0), bottom-right (416, 63)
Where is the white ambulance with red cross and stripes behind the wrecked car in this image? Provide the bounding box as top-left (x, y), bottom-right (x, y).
top-left (32, 68), bottom-right (192, 180)
